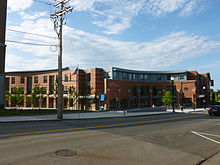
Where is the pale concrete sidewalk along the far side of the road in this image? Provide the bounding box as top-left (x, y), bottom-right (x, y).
top-left (0, 108), bottom-right (207, 123)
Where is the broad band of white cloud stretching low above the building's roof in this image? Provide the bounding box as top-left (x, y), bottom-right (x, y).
top-left (6, 18), bottom-right (220, 70)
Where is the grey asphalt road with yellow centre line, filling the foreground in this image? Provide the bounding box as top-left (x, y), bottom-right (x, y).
top-left (0, 114), bottom-right (220, 165)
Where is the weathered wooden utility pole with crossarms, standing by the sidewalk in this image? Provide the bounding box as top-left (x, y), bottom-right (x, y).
top-left (50, 0), bottom-right (72, 120)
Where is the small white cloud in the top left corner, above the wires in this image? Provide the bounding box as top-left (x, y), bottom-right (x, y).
top-left (8, 0), bottom-right (33, 12)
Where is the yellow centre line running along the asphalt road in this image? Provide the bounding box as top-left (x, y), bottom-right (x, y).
top-left (0, 115), bottom-right (204, 137)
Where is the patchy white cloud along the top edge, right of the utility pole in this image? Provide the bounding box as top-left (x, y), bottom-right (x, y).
top-left (71, 0), bottom-right (204, 34)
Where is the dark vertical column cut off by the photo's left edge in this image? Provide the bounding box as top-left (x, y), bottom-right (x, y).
top-left (0, 0), bottom-right (7, 109)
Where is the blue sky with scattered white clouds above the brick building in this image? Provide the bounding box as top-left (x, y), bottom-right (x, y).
top-left (6, 0), bottom-right (220, 89)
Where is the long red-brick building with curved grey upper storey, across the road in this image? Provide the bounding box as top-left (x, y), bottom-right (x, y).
top-left (6, 67), bottom-right (211, 110)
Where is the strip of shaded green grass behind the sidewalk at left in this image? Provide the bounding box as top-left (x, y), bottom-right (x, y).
top-left (0, 109), bottom-right (88, 116)
